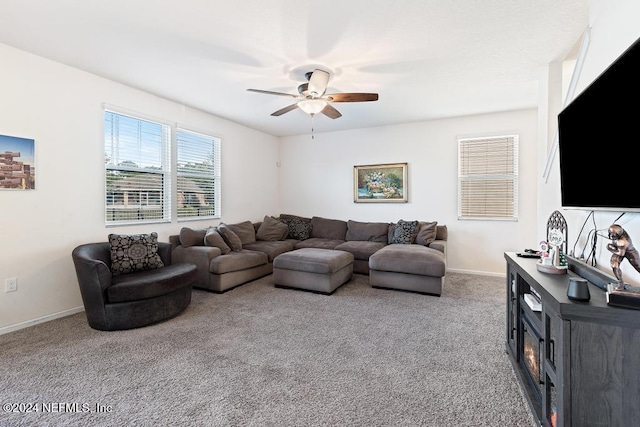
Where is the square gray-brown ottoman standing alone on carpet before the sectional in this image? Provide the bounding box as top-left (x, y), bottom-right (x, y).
top-left (273, 248), bottom-right (353, 295)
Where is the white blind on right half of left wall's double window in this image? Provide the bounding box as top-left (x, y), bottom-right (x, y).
top-left (176, 129), bottom-right (220, 220)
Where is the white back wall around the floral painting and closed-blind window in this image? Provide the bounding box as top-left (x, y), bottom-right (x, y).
top-left (280, 110), bottom-right (538, 275)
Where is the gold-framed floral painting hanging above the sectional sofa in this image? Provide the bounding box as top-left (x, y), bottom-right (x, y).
top-left (353, 163), bottom-right (408, 203)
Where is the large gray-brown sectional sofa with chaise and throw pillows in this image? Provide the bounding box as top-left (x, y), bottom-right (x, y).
top-left (169, 214), bottom-right (447, 295)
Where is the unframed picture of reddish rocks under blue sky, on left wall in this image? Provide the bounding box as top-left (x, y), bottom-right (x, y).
top-left (0, 135), bottom-right (36, 190)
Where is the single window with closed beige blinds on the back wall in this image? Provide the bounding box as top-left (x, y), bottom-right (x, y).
top-left (458, 135), bottom-right (518, 220)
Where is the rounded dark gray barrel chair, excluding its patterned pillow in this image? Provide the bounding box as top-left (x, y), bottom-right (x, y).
top-left (71, 242), bottom-right (198, 331)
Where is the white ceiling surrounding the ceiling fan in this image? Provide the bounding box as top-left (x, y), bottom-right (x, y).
top-left (0, 0), bottom-right (589, 136)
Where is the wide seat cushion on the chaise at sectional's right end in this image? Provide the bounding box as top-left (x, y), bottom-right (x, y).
top-left (369, 244), bottom-right (446, 277)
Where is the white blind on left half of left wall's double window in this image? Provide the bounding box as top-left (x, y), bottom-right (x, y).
top-left (104, 111), bottom-right (171, 224)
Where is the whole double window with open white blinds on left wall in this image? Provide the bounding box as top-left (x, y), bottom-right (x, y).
top-left (104, 110), bottom-right (221, 224)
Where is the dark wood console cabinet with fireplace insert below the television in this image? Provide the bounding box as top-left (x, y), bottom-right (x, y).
top-left (505, 253), bottom-right (640, 427)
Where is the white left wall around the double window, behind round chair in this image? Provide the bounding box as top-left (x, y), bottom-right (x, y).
top-left (0, 45), bottom-right (278, 333)
